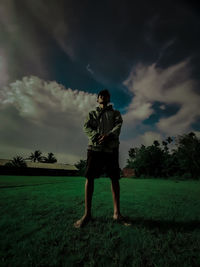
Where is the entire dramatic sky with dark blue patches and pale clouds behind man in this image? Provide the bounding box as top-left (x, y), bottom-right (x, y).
top-left (0, 0), bottom-right (200, 167)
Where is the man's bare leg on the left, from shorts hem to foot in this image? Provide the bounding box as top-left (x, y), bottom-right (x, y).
top-left (74, 179), bottom-right (94, 228)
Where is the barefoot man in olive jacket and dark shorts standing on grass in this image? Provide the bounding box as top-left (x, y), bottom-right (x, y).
top-left (74, 89), bottom-right (129, 228)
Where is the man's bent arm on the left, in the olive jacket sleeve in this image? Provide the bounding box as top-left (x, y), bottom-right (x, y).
top-left (83, 112), bottom-right (100, 142)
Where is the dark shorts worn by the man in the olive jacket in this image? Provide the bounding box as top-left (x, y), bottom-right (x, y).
top-left (85, 149), bottom-right (120, 180)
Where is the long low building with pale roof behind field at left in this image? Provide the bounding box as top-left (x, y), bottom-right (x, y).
top-left (0, 159), bottom-right (78, 176)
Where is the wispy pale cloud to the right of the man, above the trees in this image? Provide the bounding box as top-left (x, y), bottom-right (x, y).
top-left (124, 60), bottom-right (200, 135)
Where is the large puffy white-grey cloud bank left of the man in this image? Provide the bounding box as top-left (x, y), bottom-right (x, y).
top-left (0, 76), bottom-right (96, 163)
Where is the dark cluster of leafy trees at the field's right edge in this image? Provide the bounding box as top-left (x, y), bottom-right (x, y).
top-left (126, 132), bottom-right (200, 179)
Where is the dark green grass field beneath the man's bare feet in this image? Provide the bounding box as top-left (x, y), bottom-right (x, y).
top-left (0, 176), bottom-right (200, 267)
